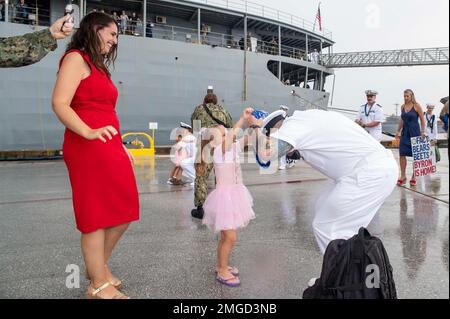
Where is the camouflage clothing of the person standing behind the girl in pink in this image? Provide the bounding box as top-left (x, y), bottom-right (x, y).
top-left (191, 104), bottom-right (233, 207)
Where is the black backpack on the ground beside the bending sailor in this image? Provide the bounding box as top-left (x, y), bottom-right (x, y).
top-left (303, 228), bottom-right (397, 299)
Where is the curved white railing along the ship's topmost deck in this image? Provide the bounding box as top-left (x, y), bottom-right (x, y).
top-left (189, 0), bottom-right (333, 40)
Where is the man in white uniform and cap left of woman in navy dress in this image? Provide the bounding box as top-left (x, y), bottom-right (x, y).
top-left (356, 90), bottom-right (385, 142)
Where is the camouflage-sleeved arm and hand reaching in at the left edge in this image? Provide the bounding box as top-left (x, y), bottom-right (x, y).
top-left (0, 15), bottom-right (73, 68)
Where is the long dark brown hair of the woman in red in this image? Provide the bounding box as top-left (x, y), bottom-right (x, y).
top-left (66, 12), bottom-right (119, 77)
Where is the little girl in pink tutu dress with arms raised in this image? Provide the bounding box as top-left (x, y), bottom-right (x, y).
top-left (202, 108), bottom-right (255, 287)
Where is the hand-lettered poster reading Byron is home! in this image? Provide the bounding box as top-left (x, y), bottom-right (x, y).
top-left (411, 136), bottom-right (436, 177)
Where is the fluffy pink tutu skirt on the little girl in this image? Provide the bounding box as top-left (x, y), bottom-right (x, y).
top-left (203, 184), bottom-right (255, 232)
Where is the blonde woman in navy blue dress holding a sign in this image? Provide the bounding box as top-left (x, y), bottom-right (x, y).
top-left (396, 90), bottom-right (426, 186)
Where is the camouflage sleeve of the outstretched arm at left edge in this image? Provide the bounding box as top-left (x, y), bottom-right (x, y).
top-left (0, 28), bottom-right (57, 68)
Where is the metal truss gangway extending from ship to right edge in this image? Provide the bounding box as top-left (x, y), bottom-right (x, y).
top-left (321, 47), bottom-right (449, 69)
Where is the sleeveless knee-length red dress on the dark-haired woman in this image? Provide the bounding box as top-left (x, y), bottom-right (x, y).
top-left (61, 50), bottom-right (139, 233)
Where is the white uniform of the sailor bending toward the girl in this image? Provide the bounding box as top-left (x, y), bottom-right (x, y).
top-left (271, 110), bottom-right (398, 253)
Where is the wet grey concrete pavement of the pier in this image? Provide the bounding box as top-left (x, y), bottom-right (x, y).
top-left (0, 150), bottom-right (449, 299)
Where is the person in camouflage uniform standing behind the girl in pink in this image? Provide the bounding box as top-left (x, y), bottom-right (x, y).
top-left (191, 87), bottom-right (233, 219)
